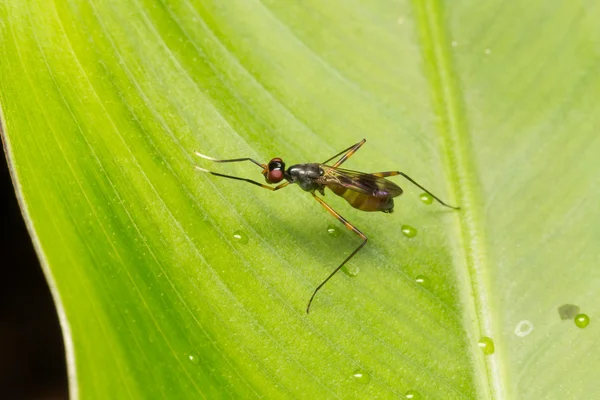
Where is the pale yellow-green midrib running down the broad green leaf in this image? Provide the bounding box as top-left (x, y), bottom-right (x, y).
top-left (413, 0), bottom-right (506, 398)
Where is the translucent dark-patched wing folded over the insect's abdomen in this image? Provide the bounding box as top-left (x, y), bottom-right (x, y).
top-left (320, 164), bottom-right (402, 197)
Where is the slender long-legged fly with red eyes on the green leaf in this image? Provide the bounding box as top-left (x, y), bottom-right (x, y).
top-left (195, 139), bottom-right (460, 314)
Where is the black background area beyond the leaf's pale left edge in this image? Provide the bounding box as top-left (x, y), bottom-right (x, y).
top-left (0, 152), bottom-right (68, 399)
